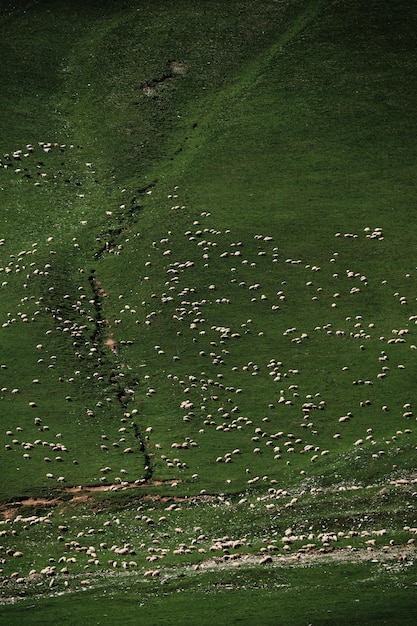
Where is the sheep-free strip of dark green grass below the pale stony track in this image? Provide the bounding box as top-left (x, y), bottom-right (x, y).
top-left (2, 564), bottom-right (416, 626)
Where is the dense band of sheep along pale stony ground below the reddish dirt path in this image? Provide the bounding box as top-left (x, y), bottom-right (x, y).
top-left (0, 481), bottom-right (417, 597)
